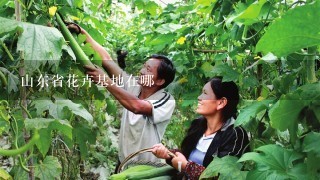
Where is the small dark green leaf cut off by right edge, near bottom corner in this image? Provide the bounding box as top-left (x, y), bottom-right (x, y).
top-left (302, 132), bottom-right (320, 157)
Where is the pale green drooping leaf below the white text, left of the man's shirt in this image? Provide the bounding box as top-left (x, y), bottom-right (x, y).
top-left (32, 99), bottom-right (93, 122)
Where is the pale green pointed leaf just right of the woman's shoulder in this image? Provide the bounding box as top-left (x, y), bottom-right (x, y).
top-left (235, 100), bottom-right (271, 126)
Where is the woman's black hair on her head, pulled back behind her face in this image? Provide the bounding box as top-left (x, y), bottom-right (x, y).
top-left (209, 77), bottom-right (239, 121)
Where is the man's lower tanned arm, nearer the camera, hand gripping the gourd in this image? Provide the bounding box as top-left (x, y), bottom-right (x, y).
top-left (85, 66), bottom-right (152, 116)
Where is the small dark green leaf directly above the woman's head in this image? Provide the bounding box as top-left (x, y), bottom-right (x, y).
top-left (211, 64), bottom-right (240, 82)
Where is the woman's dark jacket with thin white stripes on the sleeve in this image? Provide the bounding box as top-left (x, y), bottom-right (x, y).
top-left (172, 117), bottom-right (249, 179)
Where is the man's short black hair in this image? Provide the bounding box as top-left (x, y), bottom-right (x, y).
top-left (149, 54), bottom-right (176, 88)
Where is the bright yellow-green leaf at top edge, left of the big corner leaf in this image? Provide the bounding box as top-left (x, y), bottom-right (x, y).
top-left (233, 0), bottom-right (267, 25)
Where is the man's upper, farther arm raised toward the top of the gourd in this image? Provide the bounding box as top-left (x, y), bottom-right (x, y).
top-left (81, 28), bottom-right (122, 77)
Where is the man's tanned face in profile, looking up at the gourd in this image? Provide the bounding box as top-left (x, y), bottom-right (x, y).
top-left (138, 58), bottom-right (161, 86)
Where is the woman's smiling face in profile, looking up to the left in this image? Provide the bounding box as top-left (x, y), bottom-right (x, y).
top-left (196, 82), bottom-right (219, 116)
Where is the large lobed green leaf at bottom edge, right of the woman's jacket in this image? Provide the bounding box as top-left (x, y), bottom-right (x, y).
top-left (238, 144), bottom-right (306, 179)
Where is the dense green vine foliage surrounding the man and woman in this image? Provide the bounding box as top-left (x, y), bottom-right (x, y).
top-left (0, 0), bottom-right (320, 179)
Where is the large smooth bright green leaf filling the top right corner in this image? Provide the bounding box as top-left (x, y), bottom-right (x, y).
top-left (256, 1), bottom-right (320, 56)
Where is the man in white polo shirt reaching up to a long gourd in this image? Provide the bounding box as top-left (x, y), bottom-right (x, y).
top-left (69, 27), bottom-right (175, 165)
